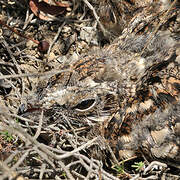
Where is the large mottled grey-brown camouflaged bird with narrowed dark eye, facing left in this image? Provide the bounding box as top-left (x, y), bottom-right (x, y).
top-left (22, 0), bottom-right (180, 168)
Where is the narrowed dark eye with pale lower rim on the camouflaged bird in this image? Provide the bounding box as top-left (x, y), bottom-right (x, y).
top-left (74, 99), bottom-right (96, 112)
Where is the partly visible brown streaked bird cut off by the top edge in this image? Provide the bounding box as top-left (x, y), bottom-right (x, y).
top-left (95, 0), bottom-right (179, 35)
